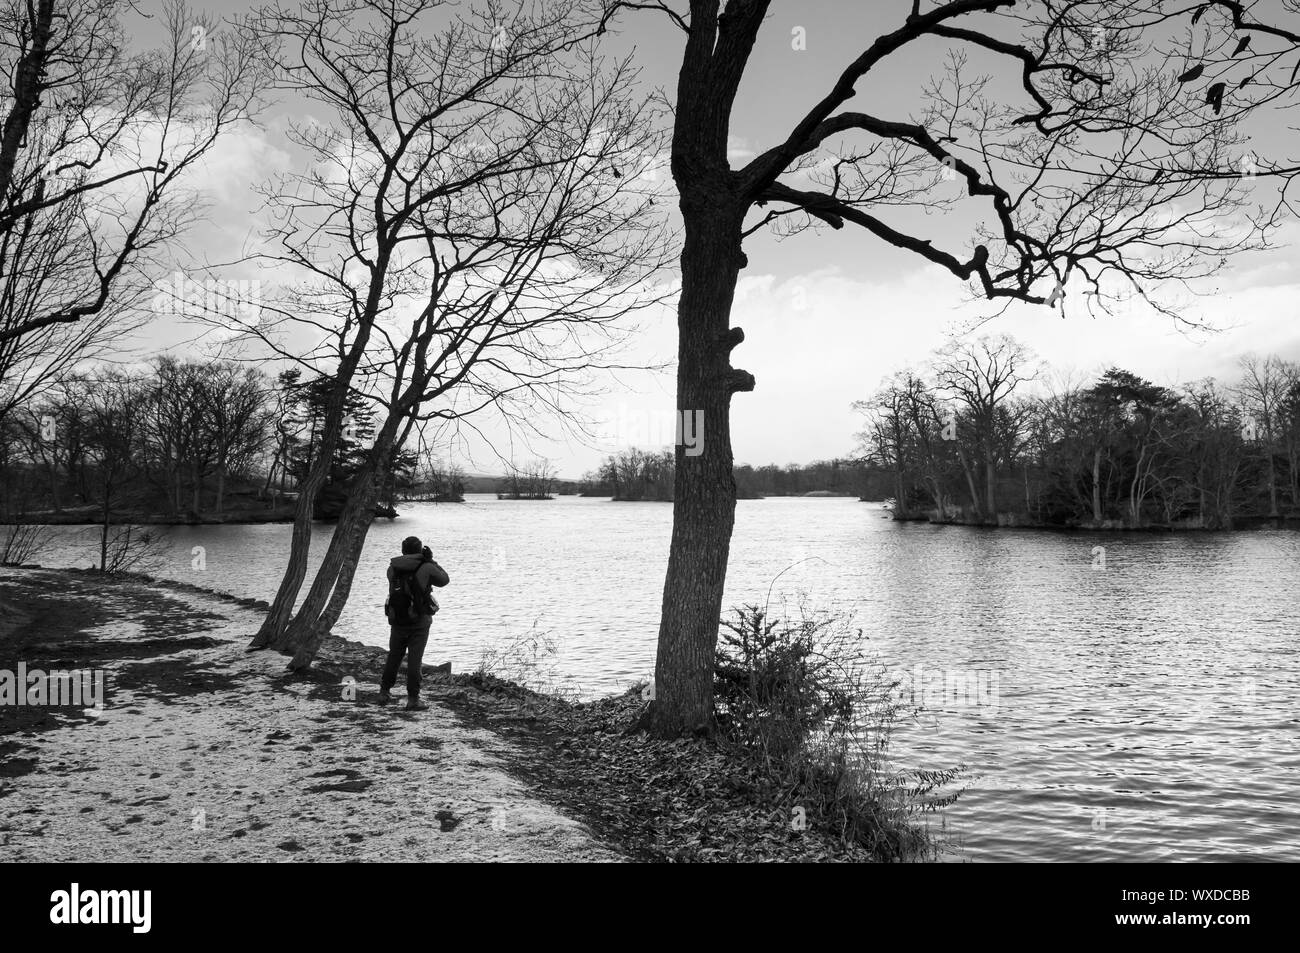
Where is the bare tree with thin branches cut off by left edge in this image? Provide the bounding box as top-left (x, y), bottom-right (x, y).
top-left (0, 0), bottom-right (260, 416)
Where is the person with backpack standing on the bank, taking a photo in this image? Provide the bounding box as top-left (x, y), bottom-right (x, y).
top-left (380, 536), bottom-right (451, 711)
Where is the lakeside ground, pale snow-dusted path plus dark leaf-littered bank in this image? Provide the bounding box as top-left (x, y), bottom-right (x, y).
top-left (0, 566), bottom-right (889, 862)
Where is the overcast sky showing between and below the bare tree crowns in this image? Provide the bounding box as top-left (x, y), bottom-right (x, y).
top-left (126, 0), bottom-right (1300, 477)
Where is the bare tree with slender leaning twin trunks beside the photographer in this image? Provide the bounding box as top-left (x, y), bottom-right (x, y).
top-left (232, 0), bottom-right (670, 667)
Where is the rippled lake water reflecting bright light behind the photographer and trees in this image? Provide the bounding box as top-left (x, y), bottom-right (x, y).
top-left (32, 497), bottom-right (1300, 862)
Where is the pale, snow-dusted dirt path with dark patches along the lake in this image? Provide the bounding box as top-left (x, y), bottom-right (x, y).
top-left (0, 568), bottom-right (620, 861)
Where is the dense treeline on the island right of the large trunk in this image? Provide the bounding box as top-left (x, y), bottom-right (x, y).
top-left (858, 337), bottom-right (1300, 528)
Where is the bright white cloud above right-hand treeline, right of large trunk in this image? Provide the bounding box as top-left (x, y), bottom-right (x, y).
top-left (732, 267), bottom-right (1300, 464)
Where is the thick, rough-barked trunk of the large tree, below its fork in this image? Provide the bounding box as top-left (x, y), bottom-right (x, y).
top-left (649, 200), bottom-right (754, 737)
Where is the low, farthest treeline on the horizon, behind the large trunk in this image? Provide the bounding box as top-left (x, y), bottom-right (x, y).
top-left (577, 447), bottom-right (879, 501)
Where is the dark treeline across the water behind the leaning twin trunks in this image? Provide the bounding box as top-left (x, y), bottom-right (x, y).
top-left (0, 358), bottom-right (464, 523)
